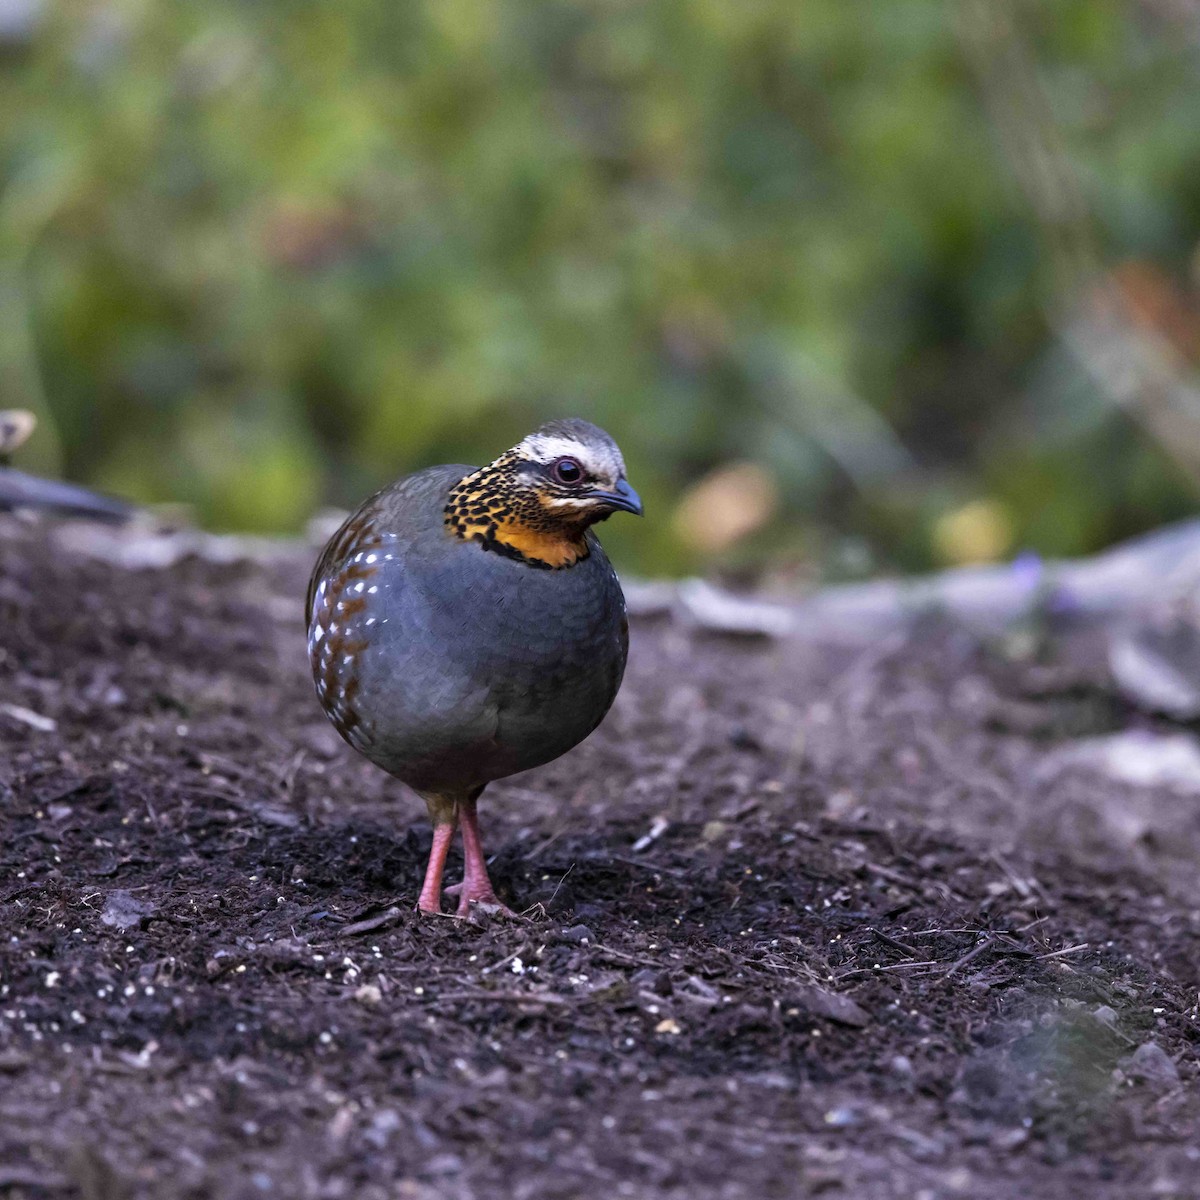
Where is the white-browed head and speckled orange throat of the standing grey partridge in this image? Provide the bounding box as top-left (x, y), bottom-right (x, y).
top-left (445, 419), bottom-right (642, 568)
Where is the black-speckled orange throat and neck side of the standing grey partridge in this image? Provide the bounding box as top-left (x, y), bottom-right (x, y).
top-left (445, 460), bottom-right (590, 570)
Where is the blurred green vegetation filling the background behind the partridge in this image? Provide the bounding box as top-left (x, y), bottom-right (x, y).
top-left (0, 0), bottom-right (1200, 576)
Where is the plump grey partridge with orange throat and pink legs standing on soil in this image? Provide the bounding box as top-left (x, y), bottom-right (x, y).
top-left (306, 418), bottom-right (643, 918)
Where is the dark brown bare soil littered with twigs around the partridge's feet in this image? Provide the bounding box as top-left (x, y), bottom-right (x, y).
top-left (0, 517), bottom-right (1200, 1200)
